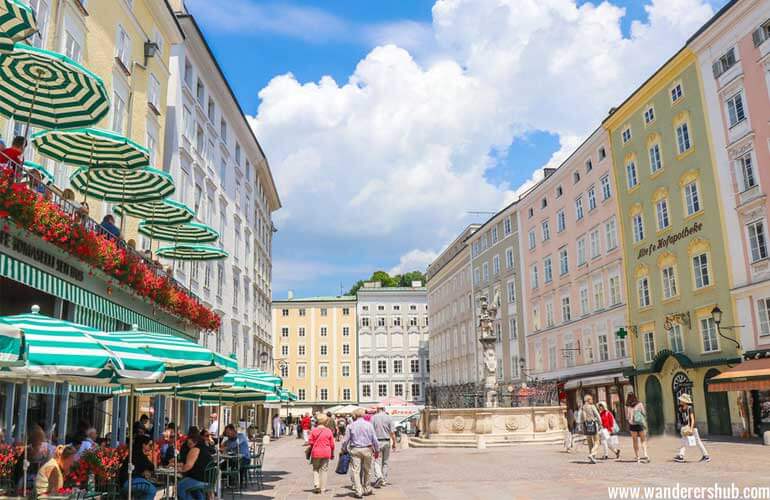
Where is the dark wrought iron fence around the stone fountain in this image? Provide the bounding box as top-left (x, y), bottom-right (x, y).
top-left (426, 380), bottom-right (559, 408)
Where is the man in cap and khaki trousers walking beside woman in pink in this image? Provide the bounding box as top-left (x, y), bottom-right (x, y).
top-left (342, 408), bottom-right (380, 498)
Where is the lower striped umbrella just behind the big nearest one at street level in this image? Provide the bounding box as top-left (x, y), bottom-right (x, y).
top-left (88, 325), bottom-right (238, 386)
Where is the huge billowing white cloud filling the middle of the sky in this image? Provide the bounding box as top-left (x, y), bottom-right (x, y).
top-left (251, 0), bottom-right (712, 282)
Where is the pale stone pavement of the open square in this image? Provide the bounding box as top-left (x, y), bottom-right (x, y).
top-left (244, 437), bottom-right (770, 500)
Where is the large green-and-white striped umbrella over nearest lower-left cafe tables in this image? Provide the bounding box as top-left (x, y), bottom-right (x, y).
top-left (0, 306), bottom-right (164, 384)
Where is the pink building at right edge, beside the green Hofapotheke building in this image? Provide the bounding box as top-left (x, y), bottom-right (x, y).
top-left (689, 0), bottom-right (770, 360)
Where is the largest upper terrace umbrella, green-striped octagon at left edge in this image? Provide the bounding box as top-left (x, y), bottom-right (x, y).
top-left (0, 43), bottom-right (110, 128)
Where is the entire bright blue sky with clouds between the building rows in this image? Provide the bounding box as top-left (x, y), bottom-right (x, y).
top-left (186, 0), bottom-right (724, 297)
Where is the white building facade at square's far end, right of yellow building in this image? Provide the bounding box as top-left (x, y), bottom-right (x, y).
top-left (357, 282), bottom-right (430, 405)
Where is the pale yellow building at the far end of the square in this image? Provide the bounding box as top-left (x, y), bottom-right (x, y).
top-left (272, 295), bottom-right (358, 416)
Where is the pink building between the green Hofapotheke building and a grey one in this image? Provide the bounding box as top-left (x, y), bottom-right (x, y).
top-left (519, 128), bottom-right (631, 415)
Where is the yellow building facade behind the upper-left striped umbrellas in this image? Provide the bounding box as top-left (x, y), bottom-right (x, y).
top-left (14, 0), bottom-right (184, 239)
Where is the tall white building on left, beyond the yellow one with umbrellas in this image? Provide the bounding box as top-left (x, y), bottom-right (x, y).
top-left (164, 7), bottom-right (281, 369)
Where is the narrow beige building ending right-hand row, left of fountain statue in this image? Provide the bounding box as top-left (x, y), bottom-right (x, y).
top-left (426, 224), bottom-right (481, 385)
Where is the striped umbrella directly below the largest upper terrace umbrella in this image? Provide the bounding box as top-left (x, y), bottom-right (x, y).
top-left (31, 128), bottom-right (150, 168)
